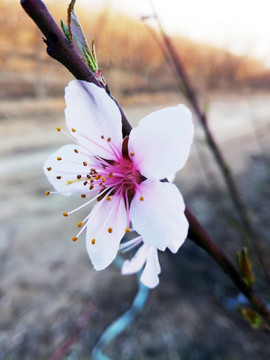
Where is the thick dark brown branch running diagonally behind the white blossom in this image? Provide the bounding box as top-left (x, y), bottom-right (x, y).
top-left (21, 0), bottom-right (270, 326)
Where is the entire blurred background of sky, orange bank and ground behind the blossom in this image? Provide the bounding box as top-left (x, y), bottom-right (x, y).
top-left (0, 0), bottom-right (270, 360)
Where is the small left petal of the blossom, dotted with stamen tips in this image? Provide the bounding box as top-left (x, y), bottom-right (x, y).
top-left (43, 145), bottom-right (92, 196)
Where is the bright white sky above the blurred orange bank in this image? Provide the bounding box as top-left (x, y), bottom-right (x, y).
top-left (77, 0), bottom-right (270, 66)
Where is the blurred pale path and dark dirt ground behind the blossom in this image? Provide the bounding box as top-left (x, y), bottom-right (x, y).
top-left (0, 90), bottom-right (270, 360)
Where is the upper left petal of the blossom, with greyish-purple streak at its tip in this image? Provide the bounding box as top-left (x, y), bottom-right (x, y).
top-left (65, 80), bottom-right (123, 159)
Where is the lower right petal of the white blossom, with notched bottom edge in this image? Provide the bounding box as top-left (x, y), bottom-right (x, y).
top-left (130, 179), bottom-right (188, 253)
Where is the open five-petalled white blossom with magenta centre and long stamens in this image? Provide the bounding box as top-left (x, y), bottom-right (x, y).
top-left (44, 80), bottom-right (194, 284)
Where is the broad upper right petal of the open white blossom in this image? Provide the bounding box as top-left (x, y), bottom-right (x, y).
top-left (128, 105), bottom-right (194, 179)
